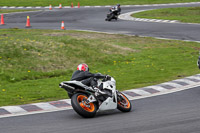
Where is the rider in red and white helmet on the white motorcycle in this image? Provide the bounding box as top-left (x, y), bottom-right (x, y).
top-left (71, 63), bottom-right (110, 90)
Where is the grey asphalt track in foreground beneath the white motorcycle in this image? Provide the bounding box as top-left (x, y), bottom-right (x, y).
top-left (0, 87), bottom-right (200, 133)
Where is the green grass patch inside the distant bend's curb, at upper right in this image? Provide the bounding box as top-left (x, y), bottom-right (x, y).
top-left (132, 7), bottom-right (200, 23)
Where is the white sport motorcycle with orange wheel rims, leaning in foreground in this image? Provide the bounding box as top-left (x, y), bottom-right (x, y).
top-left (59, 76), bottom-right (132, 118)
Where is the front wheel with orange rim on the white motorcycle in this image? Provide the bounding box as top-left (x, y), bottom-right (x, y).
top-left (117, 92), bottom-right (132, 112)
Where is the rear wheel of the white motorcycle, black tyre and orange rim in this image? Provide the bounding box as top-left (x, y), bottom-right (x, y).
top-left (71, 93), bottom-right (97, 118)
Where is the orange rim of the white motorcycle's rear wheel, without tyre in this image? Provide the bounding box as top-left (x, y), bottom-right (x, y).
top-left (77, 95), bottom-right (95, 112)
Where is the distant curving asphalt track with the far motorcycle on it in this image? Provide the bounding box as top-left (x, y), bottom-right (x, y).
top-left (0, 4), bottom-right (200, 41)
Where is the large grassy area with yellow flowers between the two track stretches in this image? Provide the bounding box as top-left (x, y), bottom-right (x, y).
top-left (0, 29), bottom-right (200, 106)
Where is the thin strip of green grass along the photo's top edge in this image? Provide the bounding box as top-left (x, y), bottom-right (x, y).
top-left (0, 0), bottom-right (199, 6)
